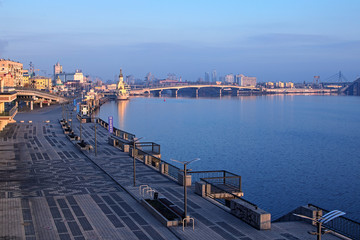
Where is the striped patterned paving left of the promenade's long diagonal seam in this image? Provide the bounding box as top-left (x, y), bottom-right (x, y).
top-left (0, 108), bottom-right (177, 240)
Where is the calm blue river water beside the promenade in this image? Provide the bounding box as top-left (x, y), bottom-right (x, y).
top-left (95, 95), bottom-right (360, 220)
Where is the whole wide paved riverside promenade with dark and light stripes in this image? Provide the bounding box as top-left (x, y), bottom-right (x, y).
top-left (0, 106), bottom-right (338, 240)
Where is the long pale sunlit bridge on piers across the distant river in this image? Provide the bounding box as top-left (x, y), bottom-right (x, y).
top-left (130, 84), bottom-right (260, 97)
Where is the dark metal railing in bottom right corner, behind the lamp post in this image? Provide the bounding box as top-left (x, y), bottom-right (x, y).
top-left (308, 203), bottom-right (360, 240)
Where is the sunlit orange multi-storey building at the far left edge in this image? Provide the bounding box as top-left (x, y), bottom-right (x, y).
top-left (0, 59), bottom-right (23, 87)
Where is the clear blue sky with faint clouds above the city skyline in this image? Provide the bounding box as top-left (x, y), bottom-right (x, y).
top-left (0, 0), bottom-right (360, 82)
